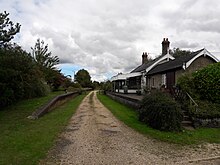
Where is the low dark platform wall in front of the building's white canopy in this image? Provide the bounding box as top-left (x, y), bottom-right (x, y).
top-left (106, 92), bottom-right (141, 109)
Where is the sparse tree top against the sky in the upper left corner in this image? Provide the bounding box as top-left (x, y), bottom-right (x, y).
top-left (0, 11), bottom-right (21, 47)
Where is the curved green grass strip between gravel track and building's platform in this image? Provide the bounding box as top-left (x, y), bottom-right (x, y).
top-left (98, 94), bottom-right (220, 145)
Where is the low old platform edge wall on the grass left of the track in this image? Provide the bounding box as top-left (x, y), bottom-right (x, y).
top-left (28, 92), bottom-right (79, 119)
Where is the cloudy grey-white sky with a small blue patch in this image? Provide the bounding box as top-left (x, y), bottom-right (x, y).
top-left (0, 0), bottom-right (220, 81)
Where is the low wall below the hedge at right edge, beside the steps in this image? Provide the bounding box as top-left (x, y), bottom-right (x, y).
top-left (193, 118), bottom-right (220, 128)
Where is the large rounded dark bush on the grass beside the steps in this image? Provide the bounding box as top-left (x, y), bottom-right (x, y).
top-left (138, 91), bottom-right (183, 131)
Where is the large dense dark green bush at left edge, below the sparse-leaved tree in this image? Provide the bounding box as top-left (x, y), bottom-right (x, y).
top-left (0, 45), bottom-right (48, 107)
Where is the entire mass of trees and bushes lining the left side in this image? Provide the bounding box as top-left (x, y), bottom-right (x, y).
top-left (0, 12), bottom-right (71, 108)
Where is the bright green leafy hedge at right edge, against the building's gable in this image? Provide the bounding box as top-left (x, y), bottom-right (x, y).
top-left (193, 63), bottom-right (220, 103)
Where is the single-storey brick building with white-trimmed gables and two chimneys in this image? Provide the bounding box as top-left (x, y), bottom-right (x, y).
top-left (111, 38), bottom-right (219, 93)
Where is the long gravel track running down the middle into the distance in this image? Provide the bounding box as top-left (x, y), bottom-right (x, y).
top-left (40, 92), bottom-right (220, 165)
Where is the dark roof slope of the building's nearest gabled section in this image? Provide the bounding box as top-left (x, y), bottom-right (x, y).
top-left (147, 49), bottom-right (204, 75)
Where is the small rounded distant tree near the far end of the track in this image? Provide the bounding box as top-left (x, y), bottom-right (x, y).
top-left (75, 69), bottom-right (92, 87)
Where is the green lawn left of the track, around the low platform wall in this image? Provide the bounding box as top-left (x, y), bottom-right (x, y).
top-left (0, 92), bottom-right (85, 165)
